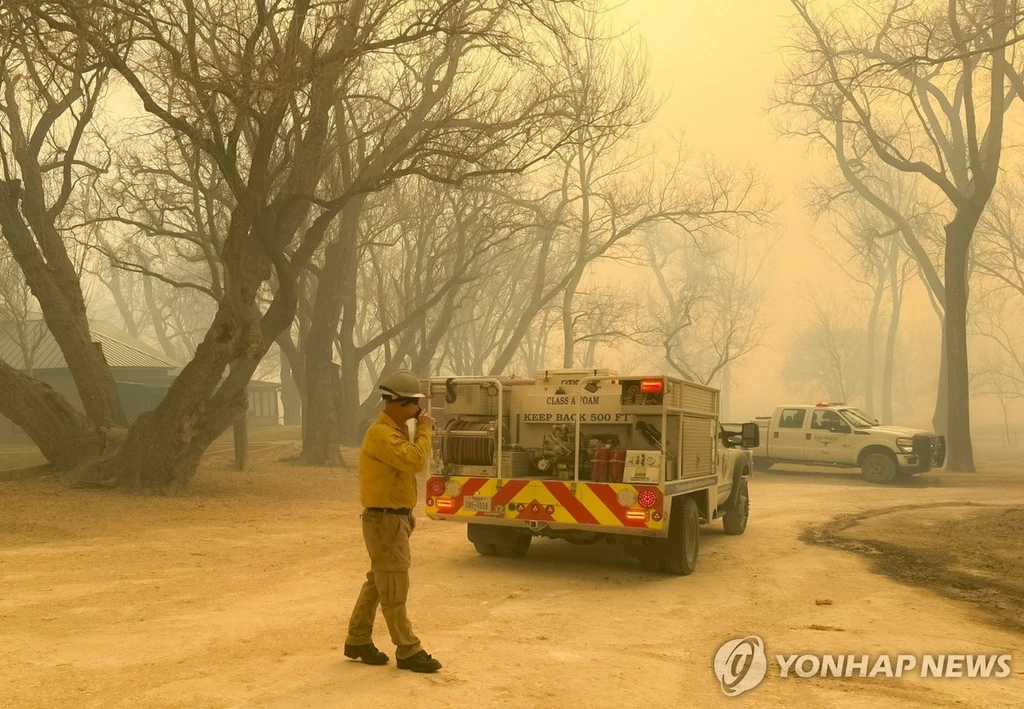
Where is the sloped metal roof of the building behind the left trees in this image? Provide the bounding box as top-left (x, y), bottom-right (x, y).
top-left (0, 320), bottom-right (180, 370)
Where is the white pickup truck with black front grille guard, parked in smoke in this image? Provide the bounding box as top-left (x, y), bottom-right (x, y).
top-left (754, 402), bottom-right (946, 485)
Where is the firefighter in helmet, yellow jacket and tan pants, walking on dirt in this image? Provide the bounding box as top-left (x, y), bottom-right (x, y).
top-left (345, 370), bottom-right (441, 672)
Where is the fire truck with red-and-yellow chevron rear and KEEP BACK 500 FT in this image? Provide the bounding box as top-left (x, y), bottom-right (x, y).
top-left (425, 369), bottom-right (759, 575)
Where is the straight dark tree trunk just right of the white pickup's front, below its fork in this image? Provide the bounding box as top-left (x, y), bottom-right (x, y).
top-left (945, 214), bottom-right (977, 472)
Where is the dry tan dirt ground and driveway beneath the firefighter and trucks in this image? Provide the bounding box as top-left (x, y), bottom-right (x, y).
top-left (0, 432), bottom-right (1024, 709)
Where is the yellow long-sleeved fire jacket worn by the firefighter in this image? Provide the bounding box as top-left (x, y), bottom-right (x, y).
top-left (359, 412), bottom-right (433, 508)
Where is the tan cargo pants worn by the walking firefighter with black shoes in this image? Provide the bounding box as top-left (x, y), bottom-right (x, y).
top-left (345, 510), bottom-right (422, 659)
